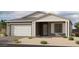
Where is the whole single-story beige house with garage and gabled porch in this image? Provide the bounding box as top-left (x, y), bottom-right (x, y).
top-left (6, 11), bottom-right (72, 37)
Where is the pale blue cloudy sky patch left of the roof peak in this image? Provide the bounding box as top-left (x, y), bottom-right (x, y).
top-left (0, 11), bottom-right (33, 20)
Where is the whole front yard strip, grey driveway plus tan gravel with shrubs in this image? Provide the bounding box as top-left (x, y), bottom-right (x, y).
top-left (0, 37), bottom-right (79, 47)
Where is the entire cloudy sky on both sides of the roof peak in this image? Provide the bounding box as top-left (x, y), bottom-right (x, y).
top-left (0, 11), bottom-right (79, 28)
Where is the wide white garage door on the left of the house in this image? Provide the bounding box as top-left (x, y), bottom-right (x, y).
top-left (11, 25), bottom-right (31, 36)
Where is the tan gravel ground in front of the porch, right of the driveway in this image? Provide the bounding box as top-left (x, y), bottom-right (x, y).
top-left (20, 37), bottom-right (79, 46)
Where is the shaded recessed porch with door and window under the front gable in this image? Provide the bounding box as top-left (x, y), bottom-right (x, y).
top-left (36, 22), bottom-right (68, 37)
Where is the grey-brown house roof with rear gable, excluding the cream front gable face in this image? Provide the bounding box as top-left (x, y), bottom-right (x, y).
top-left (6, 11), bottom-right (70, 22)
